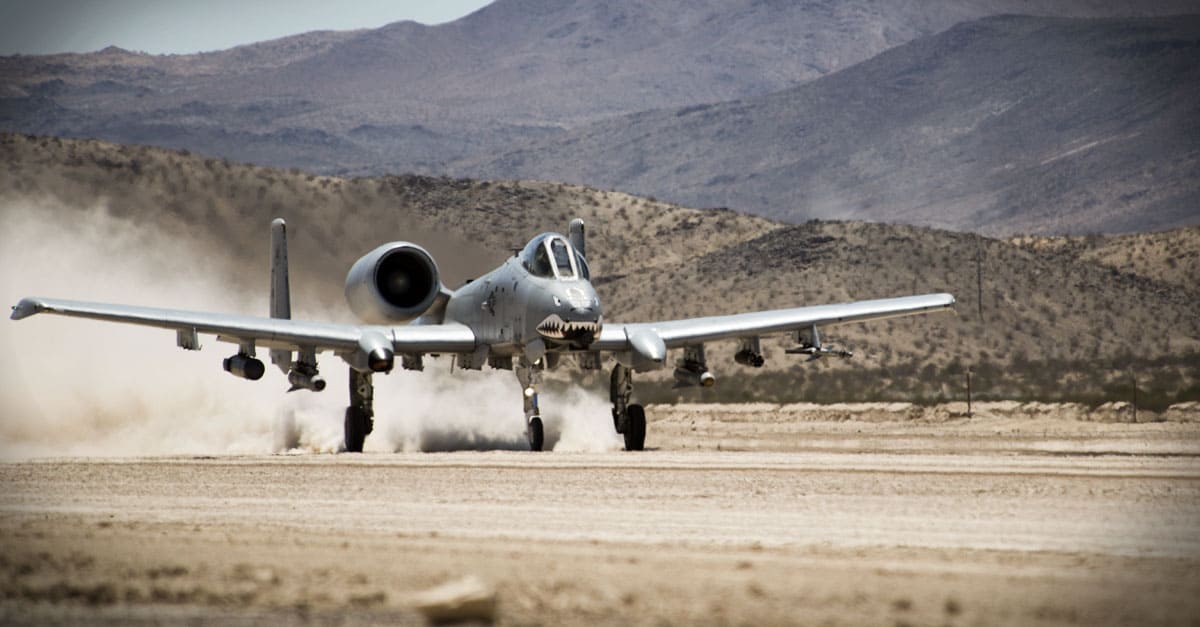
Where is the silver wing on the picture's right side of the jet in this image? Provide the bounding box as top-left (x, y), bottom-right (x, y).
top-left (592, 294), bottom-right (954, 351)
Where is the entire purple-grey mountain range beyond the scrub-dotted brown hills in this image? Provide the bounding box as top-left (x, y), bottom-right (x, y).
top-left (0, 0), bottom-right (1200, 233)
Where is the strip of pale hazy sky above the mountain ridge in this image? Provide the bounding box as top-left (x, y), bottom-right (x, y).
top-left (0, 0), bottom-right (491, 55)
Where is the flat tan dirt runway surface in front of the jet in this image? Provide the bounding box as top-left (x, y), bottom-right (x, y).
top-left (0, 405), bottom-right (1200, 626)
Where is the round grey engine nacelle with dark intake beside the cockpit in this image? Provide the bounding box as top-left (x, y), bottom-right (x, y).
top-left (346, 241), bottom-right (442, 324)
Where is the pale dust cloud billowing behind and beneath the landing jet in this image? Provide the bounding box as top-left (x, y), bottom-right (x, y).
top-left (0, 199), bottom-right (620, 459)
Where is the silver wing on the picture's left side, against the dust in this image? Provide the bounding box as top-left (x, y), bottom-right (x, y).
top-left (11, 298), bottom-right (475, 354)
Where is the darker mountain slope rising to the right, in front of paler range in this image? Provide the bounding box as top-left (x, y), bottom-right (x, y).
top-left (456, 16), bottom-right (1200, 234)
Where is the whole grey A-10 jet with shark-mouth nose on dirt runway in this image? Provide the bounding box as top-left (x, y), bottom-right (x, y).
top-left (4, 220), bottom-right (954, 452)
